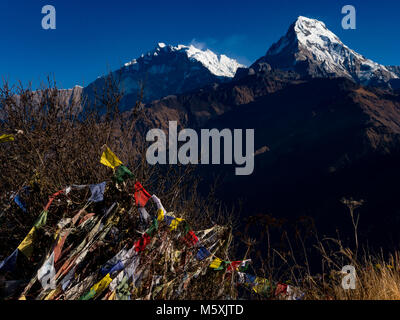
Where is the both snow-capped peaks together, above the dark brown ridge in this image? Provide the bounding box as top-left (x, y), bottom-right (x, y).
top-left (79, 16), bottom-right (400, 106)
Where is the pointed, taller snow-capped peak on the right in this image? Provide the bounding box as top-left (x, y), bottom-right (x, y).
top-left (256, 16), bottom-right (398, 84)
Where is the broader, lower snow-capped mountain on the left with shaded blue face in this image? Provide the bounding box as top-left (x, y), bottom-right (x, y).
top-left (86, 42), bottom-right (244, 108)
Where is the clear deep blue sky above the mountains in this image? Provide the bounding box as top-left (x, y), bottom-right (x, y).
top-left (0, 0), bottom-right (400, 88)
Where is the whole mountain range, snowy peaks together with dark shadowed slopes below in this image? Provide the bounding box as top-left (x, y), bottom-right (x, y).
top-left (19, 17), bottom-right (400, 244)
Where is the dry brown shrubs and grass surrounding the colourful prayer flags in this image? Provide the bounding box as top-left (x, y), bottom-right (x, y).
top-left (0, 78), bottom-right (400, 300)
